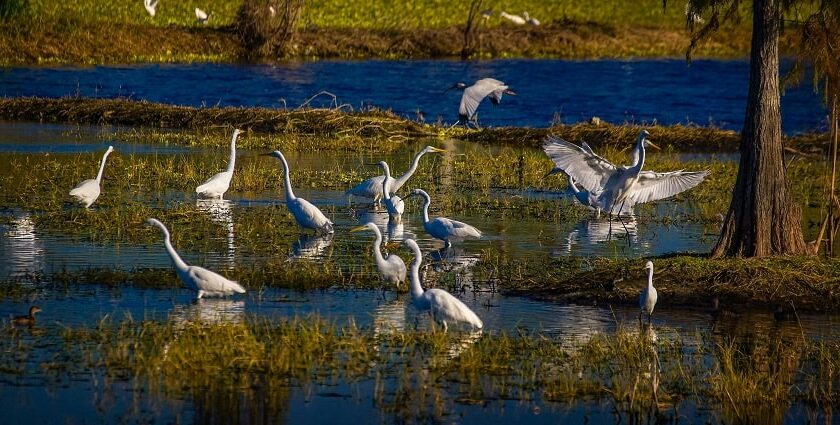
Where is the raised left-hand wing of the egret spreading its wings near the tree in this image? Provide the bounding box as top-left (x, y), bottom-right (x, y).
top-left (543, 136), bottom-right (617, 192)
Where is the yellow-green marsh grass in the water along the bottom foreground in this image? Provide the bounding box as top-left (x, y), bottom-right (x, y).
top-left (46, 316), bottom-right (840, 421)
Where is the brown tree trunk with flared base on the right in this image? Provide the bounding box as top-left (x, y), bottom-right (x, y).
top-left (712, 0), bottom-right (806, 257)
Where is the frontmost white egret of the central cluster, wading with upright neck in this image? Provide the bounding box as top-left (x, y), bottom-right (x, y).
top-left (405, 239), bottom-right (484, 332)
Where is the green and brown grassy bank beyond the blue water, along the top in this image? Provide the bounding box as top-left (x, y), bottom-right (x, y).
top-left (0, 0), bottom-right (760, 66)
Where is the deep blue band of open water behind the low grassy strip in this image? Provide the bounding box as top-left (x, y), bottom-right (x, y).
top-left (0, 59), bottom-right (825, 134)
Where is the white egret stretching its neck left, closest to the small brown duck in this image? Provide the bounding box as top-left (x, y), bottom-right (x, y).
top-left (146, 218), bottom-right (245, 299)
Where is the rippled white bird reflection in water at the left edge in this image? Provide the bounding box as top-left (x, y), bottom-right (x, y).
top-left (0, 214), bottom-right (44, 277)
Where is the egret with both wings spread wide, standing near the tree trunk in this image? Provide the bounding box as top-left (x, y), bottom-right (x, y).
top-left (543, 130), bottom-right (709, 215)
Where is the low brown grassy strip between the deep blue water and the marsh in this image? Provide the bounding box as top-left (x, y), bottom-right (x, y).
top-left (0, 97), bottom-right (828, 154)
